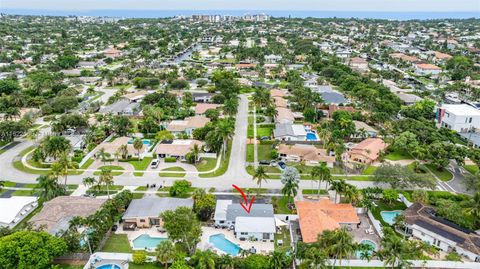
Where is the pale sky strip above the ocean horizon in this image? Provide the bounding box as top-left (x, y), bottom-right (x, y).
top-left (0, 0), bottom-right (480, 13)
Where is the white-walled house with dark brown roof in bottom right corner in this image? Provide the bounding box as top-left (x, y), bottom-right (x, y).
top-left (403, 203), bottom-right (480, 262)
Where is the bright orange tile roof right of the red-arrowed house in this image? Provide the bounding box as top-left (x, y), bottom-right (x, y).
top-left (295, 199), bottom-right (360, 243)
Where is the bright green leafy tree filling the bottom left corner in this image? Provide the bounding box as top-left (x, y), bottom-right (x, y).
top-left (0, 231), bottom-right (67, 269)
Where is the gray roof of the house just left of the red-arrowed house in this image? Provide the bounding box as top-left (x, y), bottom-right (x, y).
top-left (122, 197), bottom-right (193, 219)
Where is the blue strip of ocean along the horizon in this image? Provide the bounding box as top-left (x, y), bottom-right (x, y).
top-left (0, 9), bottom-right (480, 20)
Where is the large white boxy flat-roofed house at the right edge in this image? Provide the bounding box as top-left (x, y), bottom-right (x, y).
top-left (437, 104), bottom-right (480, 133)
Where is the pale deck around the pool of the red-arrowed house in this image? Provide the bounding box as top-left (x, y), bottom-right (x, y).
top-left (198, 227), bottom-right (275, 254)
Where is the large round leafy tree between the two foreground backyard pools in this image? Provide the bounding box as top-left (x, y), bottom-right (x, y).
top-left (161, 207), bottom-right (202, 254)
